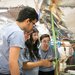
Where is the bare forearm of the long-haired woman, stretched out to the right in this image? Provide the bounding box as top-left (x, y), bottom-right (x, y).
top-left (23, 61), bottom-right (41, 69)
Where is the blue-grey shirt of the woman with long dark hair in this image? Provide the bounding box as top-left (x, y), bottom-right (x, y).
top-left (19, 49), bottom-right (39, 75)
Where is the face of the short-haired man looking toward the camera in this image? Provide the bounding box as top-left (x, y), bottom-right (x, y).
top-left (41, 37), bottom-right (50, 51)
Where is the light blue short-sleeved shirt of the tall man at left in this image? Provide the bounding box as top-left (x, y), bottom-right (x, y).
top-left (0, 22), bottom-right (24, 74)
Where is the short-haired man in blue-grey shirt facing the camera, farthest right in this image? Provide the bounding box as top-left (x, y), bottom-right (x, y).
top-left (39, 34), bottom-right (55, 75)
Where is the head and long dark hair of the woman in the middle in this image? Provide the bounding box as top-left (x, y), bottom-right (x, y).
top-left (25, 28), bottom-right (40, 60)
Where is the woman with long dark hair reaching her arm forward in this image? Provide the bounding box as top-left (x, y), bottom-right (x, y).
top-left (21, 29), bottom-right (50, 75)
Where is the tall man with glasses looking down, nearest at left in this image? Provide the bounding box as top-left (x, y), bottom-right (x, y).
top-left (0, 6), bottom-right (38, 75)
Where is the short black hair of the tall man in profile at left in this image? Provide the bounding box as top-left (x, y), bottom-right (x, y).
top-left (16, 6), bottom-right (38, 22)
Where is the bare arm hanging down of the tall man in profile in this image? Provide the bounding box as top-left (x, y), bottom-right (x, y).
top-left (9, 47), bottom-right (20, 75)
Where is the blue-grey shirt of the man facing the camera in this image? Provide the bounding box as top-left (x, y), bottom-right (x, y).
top-left (39, 47), bottom-right (55, 72)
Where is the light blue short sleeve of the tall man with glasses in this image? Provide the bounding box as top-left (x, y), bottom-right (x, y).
top-left (8, 31), bottom-right (25, 48)
